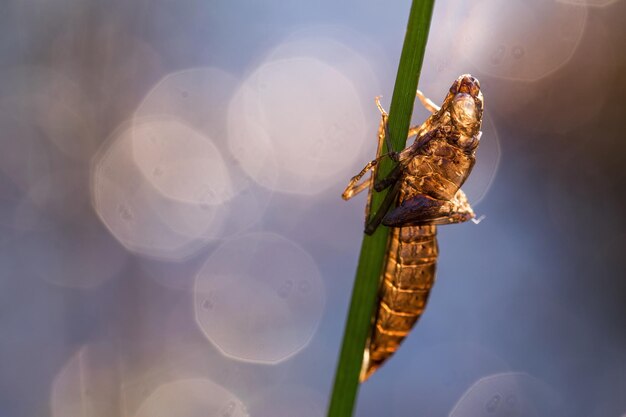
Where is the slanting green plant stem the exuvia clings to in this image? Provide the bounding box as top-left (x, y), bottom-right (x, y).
top-left (328, 0), bottom-right (435, 417)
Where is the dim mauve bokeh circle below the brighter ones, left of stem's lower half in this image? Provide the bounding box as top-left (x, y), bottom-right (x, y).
top-left (194, 233), bottom-right (325, 363)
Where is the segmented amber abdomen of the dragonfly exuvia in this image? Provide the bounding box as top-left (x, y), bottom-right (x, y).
top-left (361, 226), bottom-right (438, 381)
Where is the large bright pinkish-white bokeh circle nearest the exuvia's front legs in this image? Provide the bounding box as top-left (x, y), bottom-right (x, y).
top-left (228, 57), bottom-right (366, 195)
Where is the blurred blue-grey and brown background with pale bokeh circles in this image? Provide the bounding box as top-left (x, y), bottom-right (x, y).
top-left (0, 0), bottom-right (626, 417)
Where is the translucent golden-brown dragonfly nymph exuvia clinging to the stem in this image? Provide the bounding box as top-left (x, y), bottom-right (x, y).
top-left (342, 74), bottom-right (483, 381)
